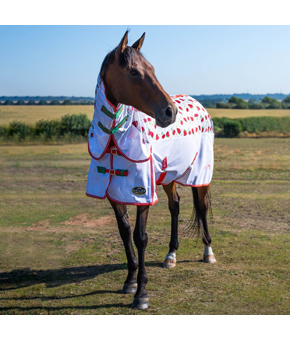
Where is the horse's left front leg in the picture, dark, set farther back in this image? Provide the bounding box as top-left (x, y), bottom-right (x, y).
top-left (109, 200), bottom-right (138, 294)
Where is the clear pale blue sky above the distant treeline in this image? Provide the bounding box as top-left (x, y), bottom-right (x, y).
top-left (0, 25), bottom-right (290, 97)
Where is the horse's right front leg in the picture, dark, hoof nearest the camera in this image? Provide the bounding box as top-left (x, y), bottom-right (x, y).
top-left (132, 205), bottom-right (149, 309)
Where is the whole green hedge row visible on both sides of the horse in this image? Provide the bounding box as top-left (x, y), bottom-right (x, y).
top-left (0, 114), bottom-right (290, 142)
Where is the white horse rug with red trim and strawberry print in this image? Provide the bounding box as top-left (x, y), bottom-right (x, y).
top-left (86, 76), bottom-right (214, 205)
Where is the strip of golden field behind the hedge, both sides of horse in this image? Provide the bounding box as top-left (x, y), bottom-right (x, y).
top-left (0, 105), bottom-right (290, 126)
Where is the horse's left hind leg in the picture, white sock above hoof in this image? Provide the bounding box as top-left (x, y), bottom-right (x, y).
top-left (163, 182), bottom-right (180, 268)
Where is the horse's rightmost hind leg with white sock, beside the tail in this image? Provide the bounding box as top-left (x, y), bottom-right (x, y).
top-left (192, 185), bottom-right (216, 263)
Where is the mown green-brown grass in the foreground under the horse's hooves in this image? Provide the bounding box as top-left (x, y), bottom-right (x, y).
top-left (0, 139), bottom-right (290, 315)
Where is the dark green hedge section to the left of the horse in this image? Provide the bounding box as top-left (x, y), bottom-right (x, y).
top-left (0, 114), bottom-right (91, 142)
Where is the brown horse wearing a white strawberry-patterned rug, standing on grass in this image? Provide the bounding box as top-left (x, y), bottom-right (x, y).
top-left (86, 31), bottom-right (216, 310)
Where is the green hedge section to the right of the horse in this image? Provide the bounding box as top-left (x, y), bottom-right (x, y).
top-left (213, 116), bottom-right (290, 137)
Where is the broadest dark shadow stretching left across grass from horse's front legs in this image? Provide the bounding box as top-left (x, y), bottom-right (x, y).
top-left (0, 262), bottom-right (161, 291)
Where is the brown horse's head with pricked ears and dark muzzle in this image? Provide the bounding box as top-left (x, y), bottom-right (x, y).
top-left (100, 31), bottom-right (177, 127)
